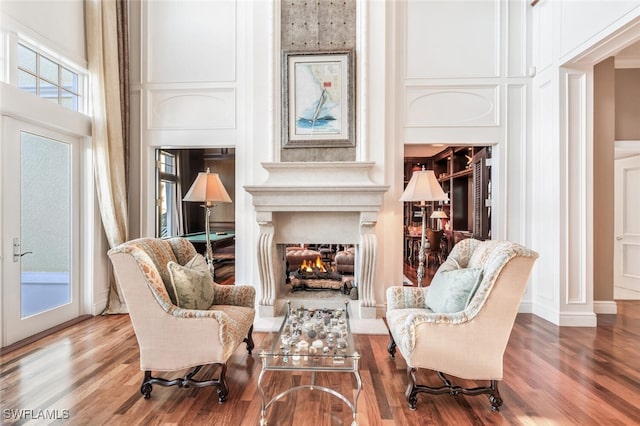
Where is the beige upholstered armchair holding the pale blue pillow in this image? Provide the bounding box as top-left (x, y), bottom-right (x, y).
top-left (386, 239), bottom-right (538, 410)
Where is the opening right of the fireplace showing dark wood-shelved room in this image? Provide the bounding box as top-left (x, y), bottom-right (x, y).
top-left (403, 144), bottom-right (492, 285)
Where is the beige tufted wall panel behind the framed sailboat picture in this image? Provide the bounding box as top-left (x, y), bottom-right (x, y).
top-left (280, 0), bottom-right (358, 161)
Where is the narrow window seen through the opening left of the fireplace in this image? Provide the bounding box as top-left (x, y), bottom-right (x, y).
top-left (157, 150), bottom-right (182, 237)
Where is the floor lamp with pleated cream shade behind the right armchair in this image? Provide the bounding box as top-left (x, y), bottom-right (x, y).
top-left (400, 167), bottom-right (449, 287)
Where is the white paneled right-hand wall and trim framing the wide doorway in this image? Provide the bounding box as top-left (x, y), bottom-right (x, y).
top-left (531, 0), bottom-right (640, 326)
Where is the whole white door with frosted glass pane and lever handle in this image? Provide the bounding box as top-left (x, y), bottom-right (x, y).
top-left (0, 117), bottom-right (84, 346)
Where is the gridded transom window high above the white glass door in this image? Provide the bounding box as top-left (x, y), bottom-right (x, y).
top-left (17, 43), bottom-right (80, 111)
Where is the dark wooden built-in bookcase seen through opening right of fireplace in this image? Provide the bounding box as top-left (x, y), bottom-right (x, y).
top-left (404, 146), bottom-right (491, 260)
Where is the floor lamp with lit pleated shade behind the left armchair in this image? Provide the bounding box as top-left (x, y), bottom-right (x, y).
top-left (183, 168), bottom-right (231, 278)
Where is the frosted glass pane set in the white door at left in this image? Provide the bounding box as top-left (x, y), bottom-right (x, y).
top-left (19, 132), bottom-right (72, 318)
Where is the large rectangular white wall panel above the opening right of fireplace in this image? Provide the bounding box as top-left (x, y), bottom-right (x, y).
top-left (405, 0), bottom-right (503, 78)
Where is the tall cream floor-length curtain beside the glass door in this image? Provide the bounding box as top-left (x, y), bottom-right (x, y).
top-left (85, 0), bottom-right (129, 313)
